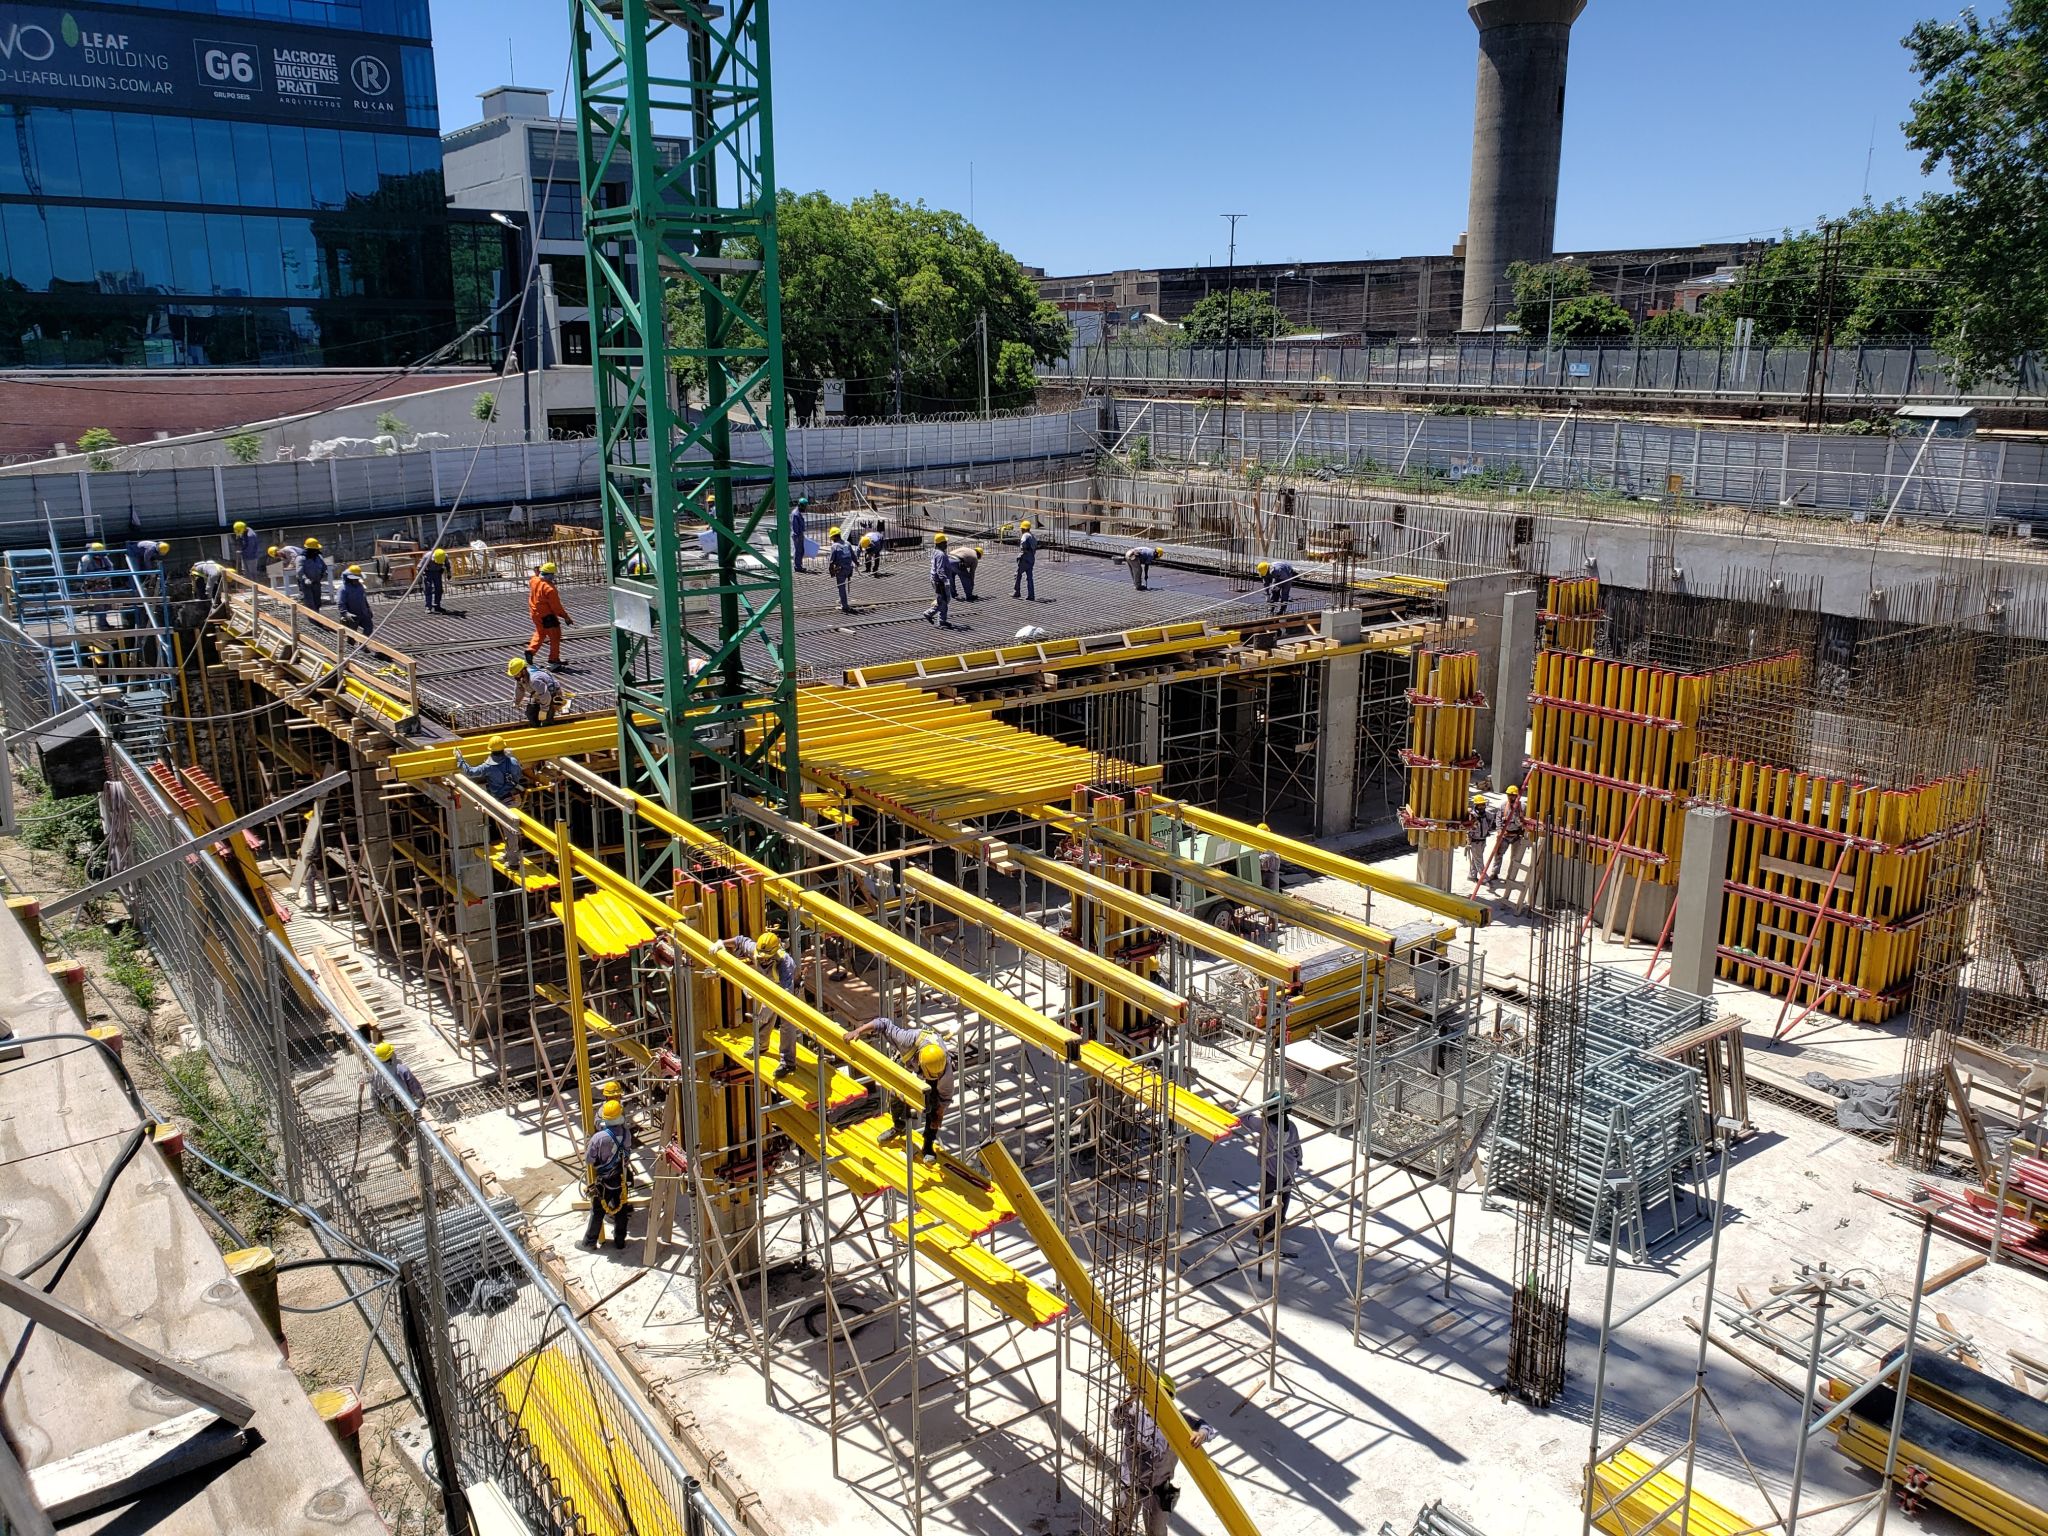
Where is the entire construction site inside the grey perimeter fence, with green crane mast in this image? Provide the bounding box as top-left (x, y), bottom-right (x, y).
top-left (0, 0), bottom-right (2048, 1536)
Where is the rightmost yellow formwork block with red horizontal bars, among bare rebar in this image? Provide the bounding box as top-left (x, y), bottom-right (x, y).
top-left (1698, 756), bottom-right (1985, 1024)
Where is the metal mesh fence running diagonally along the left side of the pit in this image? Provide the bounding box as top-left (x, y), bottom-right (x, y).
top-left (0, 631), bottom-right (731, 1536)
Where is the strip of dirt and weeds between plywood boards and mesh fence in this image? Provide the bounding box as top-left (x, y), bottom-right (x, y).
top-left (0, 806), bottom-right (446, 1536)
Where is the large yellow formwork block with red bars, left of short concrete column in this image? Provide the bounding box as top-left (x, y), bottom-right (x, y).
top-left (1524, 651), bottom-right (1800, 885)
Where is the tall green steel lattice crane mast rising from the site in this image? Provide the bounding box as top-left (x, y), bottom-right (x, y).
top-left (571, 0), bottom-right (797, 860)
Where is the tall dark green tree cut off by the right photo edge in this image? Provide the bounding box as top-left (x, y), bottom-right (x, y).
top-left (1905, 0), bottom-right (2048, 377)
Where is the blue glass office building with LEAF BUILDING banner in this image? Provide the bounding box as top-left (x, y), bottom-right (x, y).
top-left (0, 0), bottom-right (506, 367)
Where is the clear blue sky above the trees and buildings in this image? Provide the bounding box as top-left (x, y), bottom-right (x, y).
top-left (434, 0), bottom-right (1949, 272)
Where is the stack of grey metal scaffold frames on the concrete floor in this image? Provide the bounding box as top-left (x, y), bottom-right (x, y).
top-left (1491, 967), bottom-right (1714, 1262)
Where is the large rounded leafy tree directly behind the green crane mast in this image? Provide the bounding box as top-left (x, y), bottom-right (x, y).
top-left (668, 193), bottom-right (1071, 418)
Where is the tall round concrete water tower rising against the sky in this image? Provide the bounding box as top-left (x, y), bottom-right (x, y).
top-left (1460, 0), bottom-right (1585, 330)
